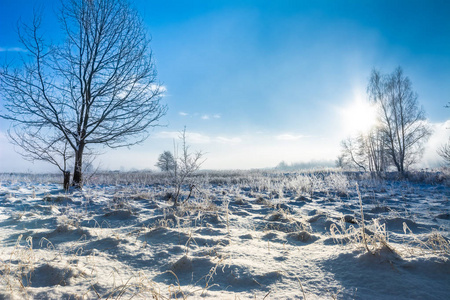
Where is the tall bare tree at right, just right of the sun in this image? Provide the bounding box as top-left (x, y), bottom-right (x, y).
top-left (367, 67), bottom-right (431, 175)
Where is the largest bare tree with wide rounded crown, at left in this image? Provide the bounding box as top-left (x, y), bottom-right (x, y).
top-left (0, 0), bottom-right (166, 186)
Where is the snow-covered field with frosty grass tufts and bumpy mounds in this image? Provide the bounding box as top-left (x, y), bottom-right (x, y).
top-left (0, 171), bottom-right (450, 299)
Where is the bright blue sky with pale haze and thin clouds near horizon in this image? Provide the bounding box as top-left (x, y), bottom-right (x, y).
top-left (0, 0), bottom-right (450, 171)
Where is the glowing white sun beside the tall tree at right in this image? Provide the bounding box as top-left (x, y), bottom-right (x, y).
top-left (341, 97), bottom-right (377, 134)
